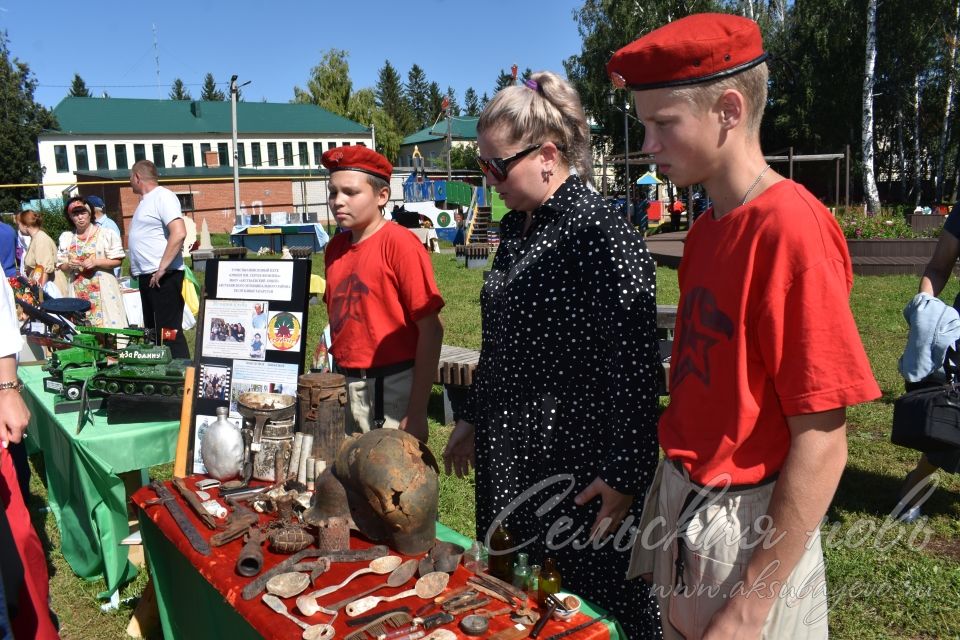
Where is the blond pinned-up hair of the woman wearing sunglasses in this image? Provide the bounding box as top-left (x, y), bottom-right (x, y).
top-left (477, 71), bottom-right (593, 183)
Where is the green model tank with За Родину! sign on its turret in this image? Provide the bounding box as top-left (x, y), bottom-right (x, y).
top-left (87, 344), bottom-right (189, 397)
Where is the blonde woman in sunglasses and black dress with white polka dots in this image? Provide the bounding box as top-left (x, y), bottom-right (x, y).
top-left (444, 72), bottom-right (660, 639)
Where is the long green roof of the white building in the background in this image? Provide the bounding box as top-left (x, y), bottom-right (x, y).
top-left (53, 97), bottom-right (370, 135)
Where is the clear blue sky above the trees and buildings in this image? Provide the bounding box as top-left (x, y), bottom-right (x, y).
top-left (0, 0), bottom-right (582, 107)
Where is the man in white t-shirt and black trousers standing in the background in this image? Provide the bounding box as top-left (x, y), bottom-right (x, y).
top-left (127, 160), bottom-right (190, 358)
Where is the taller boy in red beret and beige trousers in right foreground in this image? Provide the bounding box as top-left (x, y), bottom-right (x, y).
top-left (607, 14), bottom-right (880, 640)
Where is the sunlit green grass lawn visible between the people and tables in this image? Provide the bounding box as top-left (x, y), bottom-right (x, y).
top-left (31, 246), bottom-right (960, 640)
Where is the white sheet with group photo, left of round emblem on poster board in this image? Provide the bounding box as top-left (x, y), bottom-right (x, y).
top-left (203, 300), bottom-right (269, 360)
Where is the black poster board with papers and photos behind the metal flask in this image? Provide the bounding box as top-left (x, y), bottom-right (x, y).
top-left (187, 260), bottom-right (312, 473)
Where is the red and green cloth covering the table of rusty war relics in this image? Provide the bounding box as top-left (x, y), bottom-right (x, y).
top-left (133, 476), bottom-right (623, 640)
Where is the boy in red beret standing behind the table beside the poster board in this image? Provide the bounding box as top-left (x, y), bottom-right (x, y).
top-left (322, 146), bottom-right (443, 442)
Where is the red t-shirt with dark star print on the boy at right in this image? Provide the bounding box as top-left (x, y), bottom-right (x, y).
top-left (659, 180), bottom-right (880, 484)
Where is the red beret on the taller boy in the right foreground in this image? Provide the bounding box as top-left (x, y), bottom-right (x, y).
top-left (607, 13), bottom-right (769, 91)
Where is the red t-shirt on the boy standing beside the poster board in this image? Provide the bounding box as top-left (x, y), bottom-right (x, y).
top-left (324, 222), bottom-right (443, 369)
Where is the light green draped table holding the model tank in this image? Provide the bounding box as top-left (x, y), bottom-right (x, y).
top-left (20, 366), bottom-right (180, 597)
